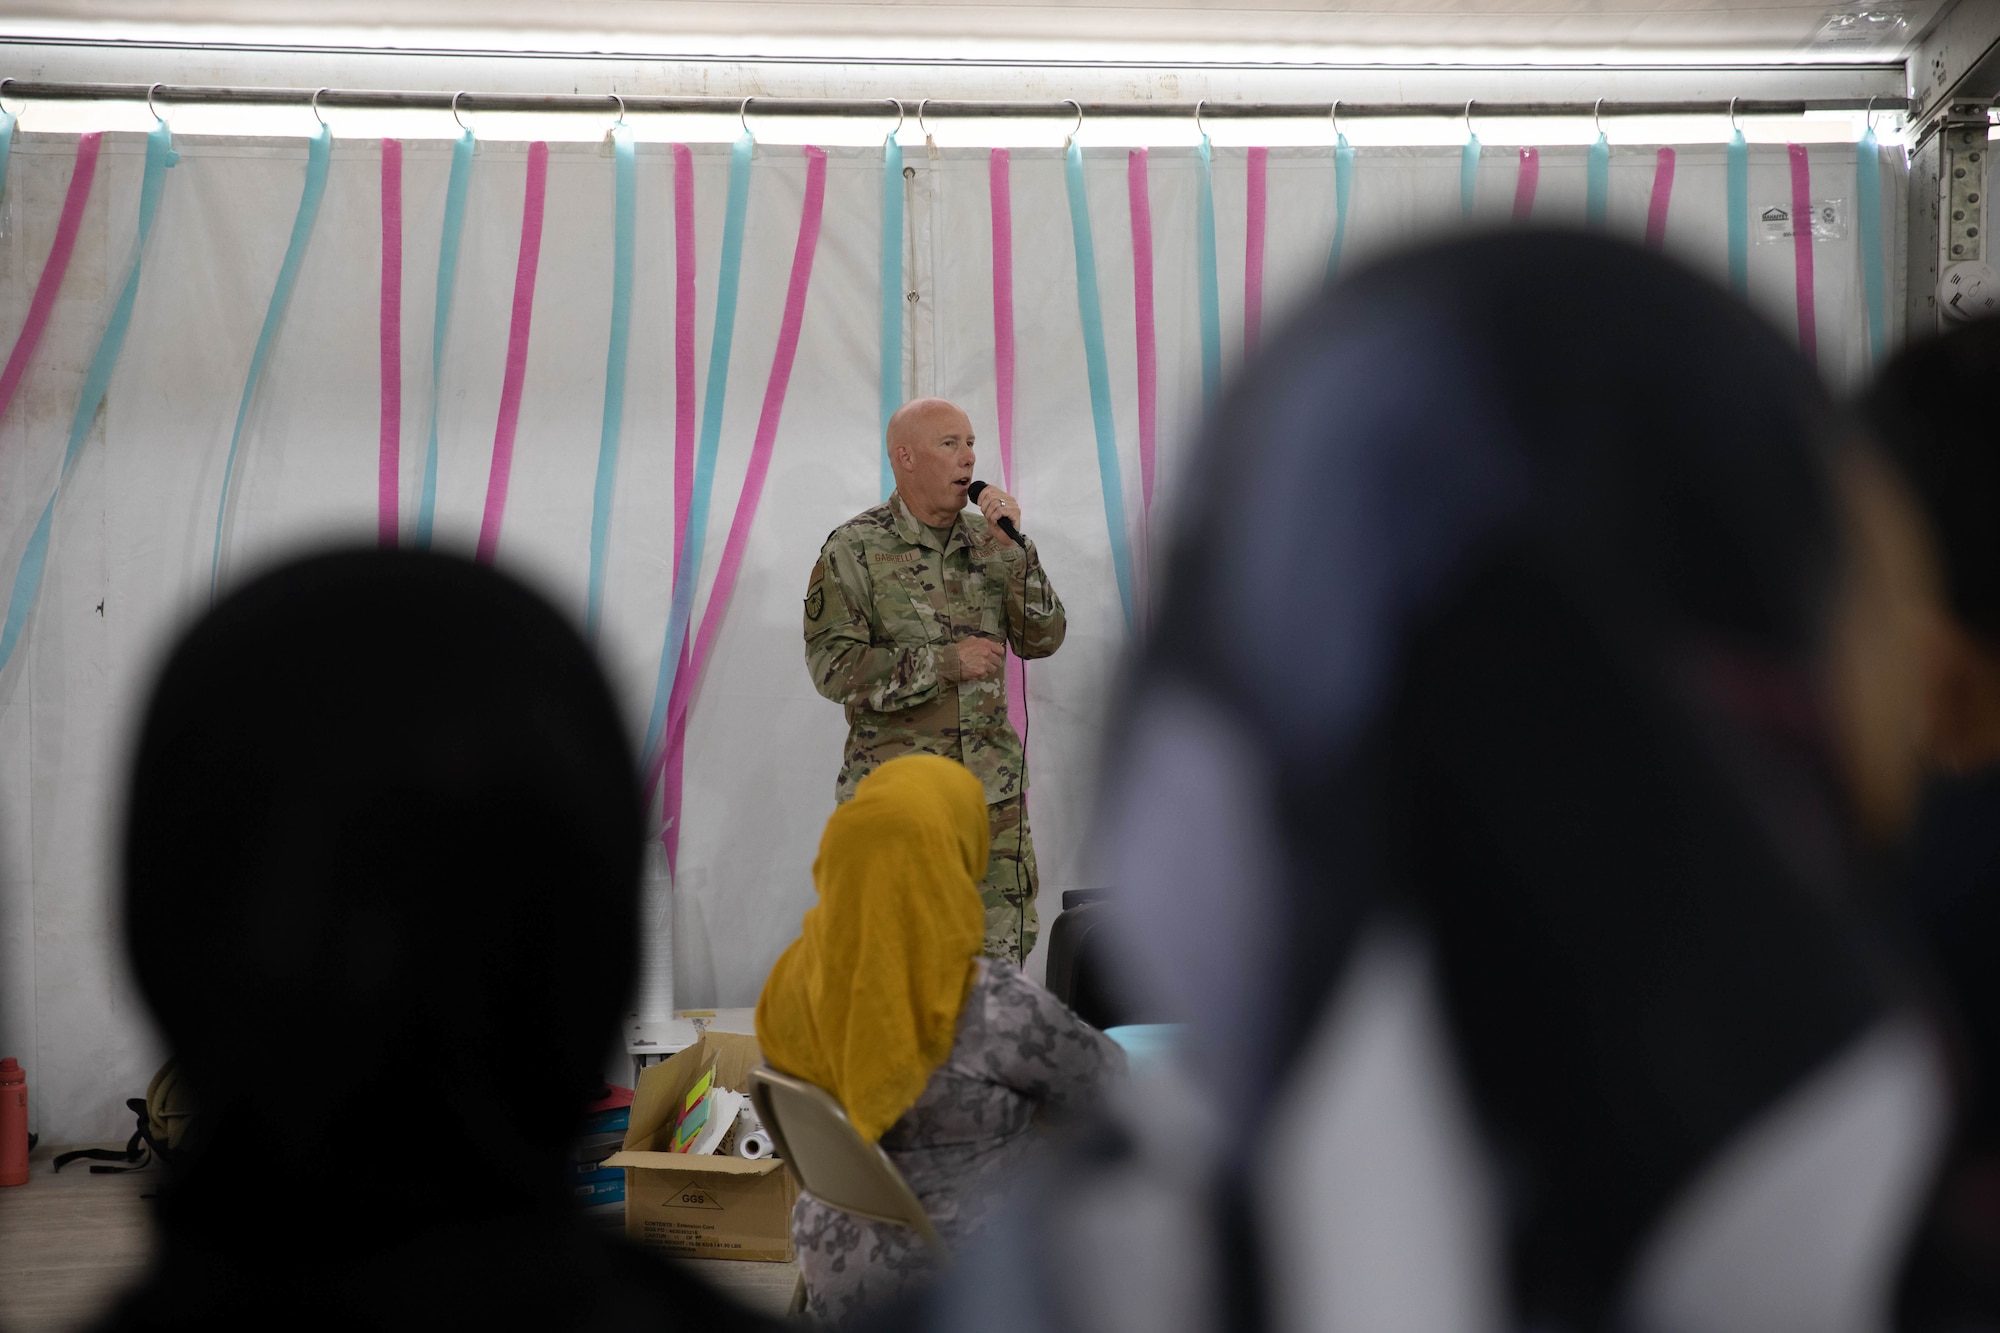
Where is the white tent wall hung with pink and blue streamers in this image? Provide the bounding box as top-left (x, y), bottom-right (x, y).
top-left (0, 134), bottom-right (1904, 1141)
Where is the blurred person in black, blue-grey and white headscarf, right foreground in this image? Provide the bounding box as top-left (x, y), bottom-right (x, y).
top-left (904, 232), bottom-right (1942, 1333)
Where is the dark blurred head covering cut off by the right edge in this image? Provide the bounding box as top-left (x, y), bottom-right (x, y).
top-left (1860, 318), bottom-right (2000, 642)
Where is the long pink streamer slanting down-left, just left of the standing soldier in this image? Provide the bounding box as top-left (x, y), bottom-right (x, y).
top-left (662, 144), bottom-right (826, 861)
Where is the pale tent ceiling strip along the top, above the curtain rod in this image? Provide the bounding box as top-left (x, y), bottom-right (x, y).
top-left (0, 0), bottom-right (1948, 62)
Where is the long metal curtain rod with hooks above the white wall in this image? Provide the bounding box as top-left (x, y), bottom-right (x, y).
top-left (0, 78), bottom-right (1910, 120)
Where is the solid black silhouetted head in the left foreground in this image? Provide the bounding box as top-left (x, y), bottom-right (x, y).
top-left (124, 550), bottom-right (764, 1327)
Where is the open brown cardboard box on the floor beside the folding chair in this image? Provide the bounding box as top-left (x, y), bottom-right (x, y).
top-left (604, 1033), bottom-right (798, 1261)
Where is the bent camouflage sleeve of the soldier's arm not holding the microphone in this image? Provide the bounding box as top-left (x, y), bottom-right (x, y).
top-left (806, 536), bottom-right (948, 713)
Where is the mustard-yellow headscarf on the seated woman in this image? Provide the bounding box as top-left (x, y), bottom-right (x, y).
top-left (756, 755), bottom-right (988, 1141)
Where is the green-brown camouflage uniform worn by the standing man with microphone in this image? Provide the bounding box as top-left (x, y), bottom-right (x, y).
top-left (806, 494), bottom-right (1068, 963)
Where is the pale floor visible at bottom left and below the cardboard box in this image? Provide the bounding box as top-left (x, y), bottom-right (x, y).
top-left (0, 1145), bottom-right (796, 1333)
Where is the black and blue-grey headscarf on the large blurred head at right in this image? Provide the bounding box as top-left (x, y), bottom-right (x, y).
top-left (1110, 232), bottom-right (1884, 1327)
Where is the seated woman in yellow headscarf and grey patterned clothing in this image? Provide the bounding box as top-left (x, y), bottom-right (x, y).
top-left (756, 755), bottom-right (1124, 1323)
